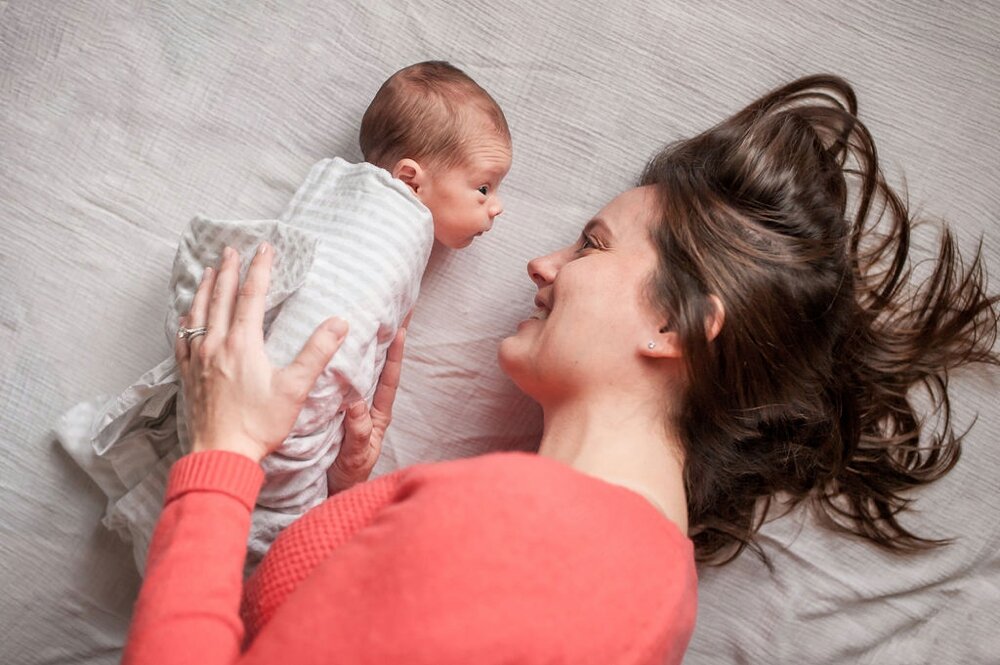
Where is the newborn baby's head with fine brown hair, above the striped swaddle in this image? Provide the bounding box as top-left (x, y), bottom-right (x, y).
top-left (361, 61), bottom-right (511, 249)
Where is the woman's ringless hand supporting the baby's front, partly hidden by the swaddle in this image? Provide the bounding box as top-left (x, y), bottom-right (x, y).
top-left (326, 316), bottom-right (410, 496)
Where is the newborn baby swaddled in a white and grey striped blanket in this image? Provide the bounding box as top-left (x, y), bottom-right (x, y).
top-left (57, 61), bottom-right (511, 570)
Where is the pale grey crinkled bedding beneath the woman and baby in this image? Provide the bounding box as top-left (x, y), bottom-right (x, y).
top-left (0, 0), bottom-right (1000, 665)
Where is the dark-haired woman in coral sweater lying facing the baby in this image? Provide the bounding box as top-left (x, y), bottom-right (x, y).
top-left (125, 77), bottom-right (997, 663)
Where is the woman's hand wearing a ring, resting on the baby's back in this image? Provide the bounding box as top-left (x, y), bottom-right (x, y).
top-left (174, 243), bottom-right (350, 462)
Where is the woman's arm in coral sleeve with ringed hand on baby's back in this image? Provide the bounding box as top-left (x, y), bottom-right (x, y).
top-left (124, 244), bottom-right (347, 665)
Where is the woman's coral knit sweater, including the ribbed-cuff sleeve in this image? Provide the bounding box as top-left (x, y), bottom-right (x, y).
top-left (123, 451), bottom-right (697, 665)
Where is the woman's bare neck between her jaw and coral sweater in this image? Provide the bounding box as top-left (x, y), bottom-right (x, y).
top-left (538, 398), bottom-right (687, 533)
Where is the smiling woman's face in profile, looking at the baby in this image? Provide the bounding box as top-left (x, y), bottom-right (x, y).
top-left (499, 187), bottom-right (665, 406)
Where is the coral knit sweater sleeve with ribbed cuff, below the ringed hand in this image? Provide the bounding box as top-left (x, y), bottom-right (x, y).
top-left (122, 451), bottom-right (263, 665)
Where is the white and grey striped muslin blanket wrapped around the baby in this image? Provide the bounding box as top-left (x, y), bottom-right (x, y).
top-left (56, 158), bottom-right (434, 572)
